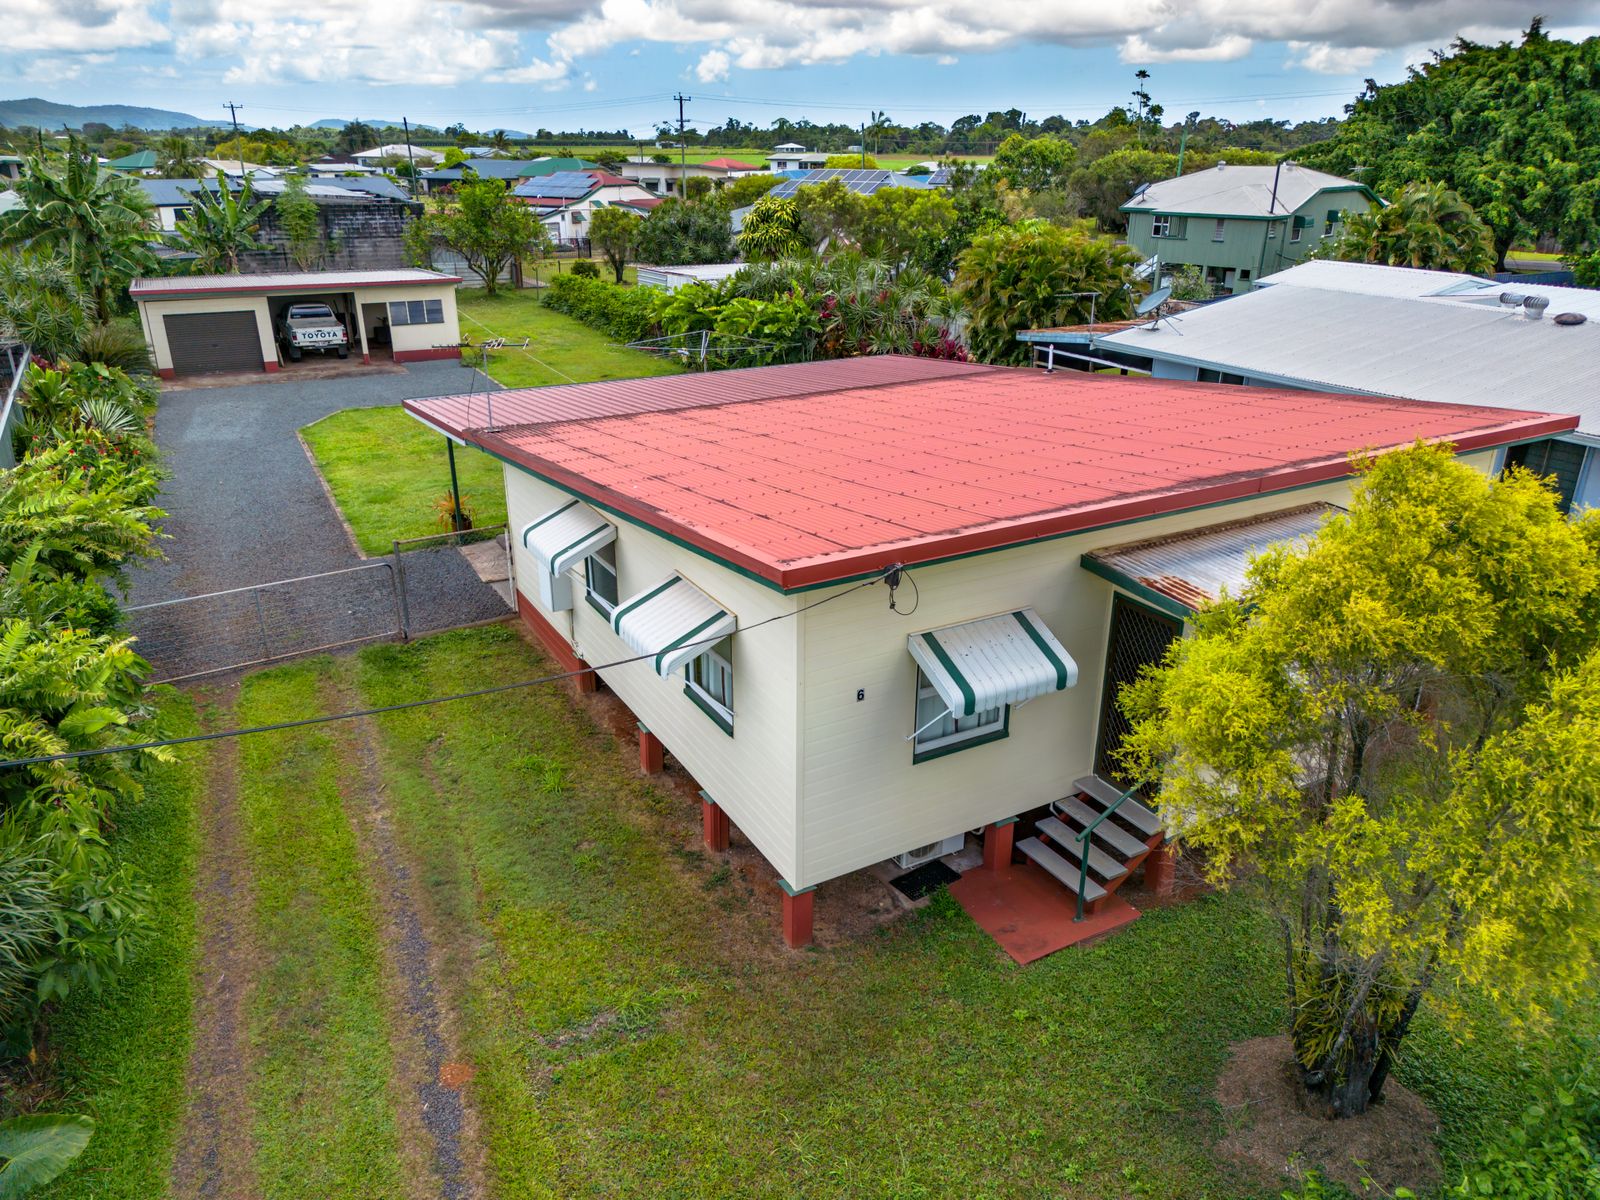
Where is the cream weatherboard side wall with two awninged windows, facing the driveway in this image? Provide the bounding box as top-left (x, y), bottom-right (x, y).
top-left (506, 466), bottom-right (802, 886)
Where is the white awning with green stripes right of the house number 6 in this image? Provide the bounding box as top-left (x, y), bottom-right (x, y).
top-left (907, 608), bottom-right (1078, 717)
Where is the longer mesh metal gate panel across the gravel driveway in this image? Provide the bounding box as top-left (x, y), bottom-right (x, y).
top-left (123, 558), bottom-right (405, 683)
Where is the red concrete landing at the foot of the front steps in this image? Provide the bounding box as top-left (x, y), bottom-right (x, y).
top-left (950, 862), bottom-right (1139, 965)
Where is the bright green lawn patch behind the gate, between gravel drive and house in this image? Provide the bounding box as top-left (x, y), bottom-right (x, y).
top-left (301, 408), bottom-right (506, 555)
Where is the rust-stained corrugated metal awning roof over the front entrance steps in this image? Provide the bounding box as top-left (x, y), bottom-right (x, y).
top-left (1083, 504), bottom-right (1342, 610)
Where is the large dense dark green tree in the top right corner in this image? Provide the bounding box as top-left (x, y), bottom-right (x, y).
top-left (1302, 19), bottom-right (1600, 269)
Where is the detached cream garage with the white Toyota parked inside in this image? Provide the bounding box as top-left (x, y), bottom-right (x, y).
top-left (128, 269), bottom-right (461, 379)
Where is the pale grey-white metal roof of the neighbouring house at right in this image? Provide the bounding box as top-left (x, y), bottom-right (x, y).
top-left (1096, 276), bottom-right (1600, 435)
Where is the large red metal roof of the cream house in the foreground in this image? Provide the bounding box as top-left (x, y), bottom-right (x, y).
top-left (405, 357), bottom-right (1578, 587)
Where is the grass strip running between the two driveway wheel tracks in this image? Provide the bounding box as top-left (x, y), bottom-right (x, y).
top-left (237, 659), bottom-right (405, 1200)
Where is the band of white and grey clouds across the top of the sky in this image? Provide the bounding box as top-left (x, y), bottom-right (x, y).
top-left (0, 0), bottom-right (1600, 88)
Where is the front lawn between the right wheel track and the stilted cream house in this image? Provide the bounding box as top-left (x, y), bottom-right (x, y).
top-left (350, 629), bottom-right (1312, 1197)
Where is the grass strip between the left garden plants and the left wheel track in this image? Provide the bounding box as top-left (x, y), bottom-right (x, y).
top-left (40, 688), bottom-right (206, 1200)
